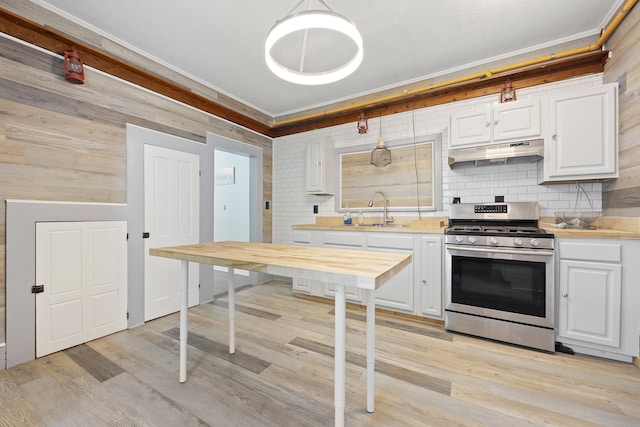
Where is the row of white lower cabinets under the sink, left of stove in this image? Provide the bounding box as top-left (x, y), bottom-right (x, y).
top-left (293, 230), bottom-right (443, 319)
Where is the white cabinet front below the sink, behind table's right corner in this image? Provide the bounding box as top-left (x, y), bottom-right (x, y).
top-left (367, 233), bottom-right (415, 313)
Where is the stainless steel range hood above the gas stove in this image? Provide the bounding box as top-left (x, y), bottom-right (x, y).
top-left (449, 139), bottom-right (544, 167)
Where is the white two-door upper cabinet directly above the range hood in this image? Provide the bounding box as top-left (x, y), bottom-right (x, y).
top-left (449, 99), bottom-right (542, 149)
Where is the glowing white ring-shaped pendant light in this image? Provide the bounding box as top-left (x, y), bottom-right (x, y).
top-left (264, 10), bottom-right (363, 85)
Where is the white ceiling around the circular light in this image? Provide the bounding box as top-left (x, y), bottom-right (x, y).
top-left (32, 0), bottom-right (624, 117)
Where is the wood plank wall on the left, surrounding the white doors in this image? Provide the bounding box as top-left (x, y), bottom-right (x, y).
top-left (0, 37), bottom-right (272, 343)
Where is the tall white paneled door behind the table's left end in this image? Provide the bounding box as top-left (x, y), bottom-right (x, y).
top-left (144, 145), bottom-right (200, 321)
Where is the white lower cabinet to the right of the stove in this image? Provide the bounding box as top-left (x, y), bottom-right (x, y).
top-left (557, 239), bottom-right (640, 361)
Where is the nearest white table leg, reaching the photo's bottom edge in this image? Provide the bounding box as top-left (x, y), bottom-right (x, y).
top-left (333, 285), bottom-right (347, 427)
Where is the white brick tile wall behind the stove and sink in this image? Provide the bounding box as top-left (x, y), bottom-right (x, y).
top-left (273, 74), bottom-right (602, 244)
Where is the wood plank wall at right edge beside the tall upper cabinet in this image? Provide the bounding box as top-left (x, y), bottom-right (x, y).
top-left (602, 5), bottom-right (640, 217)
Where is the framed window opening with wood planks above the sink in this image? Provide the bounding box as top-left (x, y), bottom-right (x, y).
top-left (336, 133), bottom-right (442, 212)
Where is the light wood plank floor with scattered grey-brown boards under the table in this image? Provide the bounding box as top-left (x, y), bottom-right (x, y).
top-left (0, 282), bottom-right (640, 427)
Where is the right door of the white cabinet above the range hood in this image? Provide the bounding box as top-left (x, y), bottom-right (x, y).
top-left (493, 99), bottom-right (542, 142)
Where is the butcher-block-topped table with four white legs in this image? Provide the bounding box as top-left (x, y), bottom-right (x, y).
top-left (149, 242), bottom-right (411, 426)
